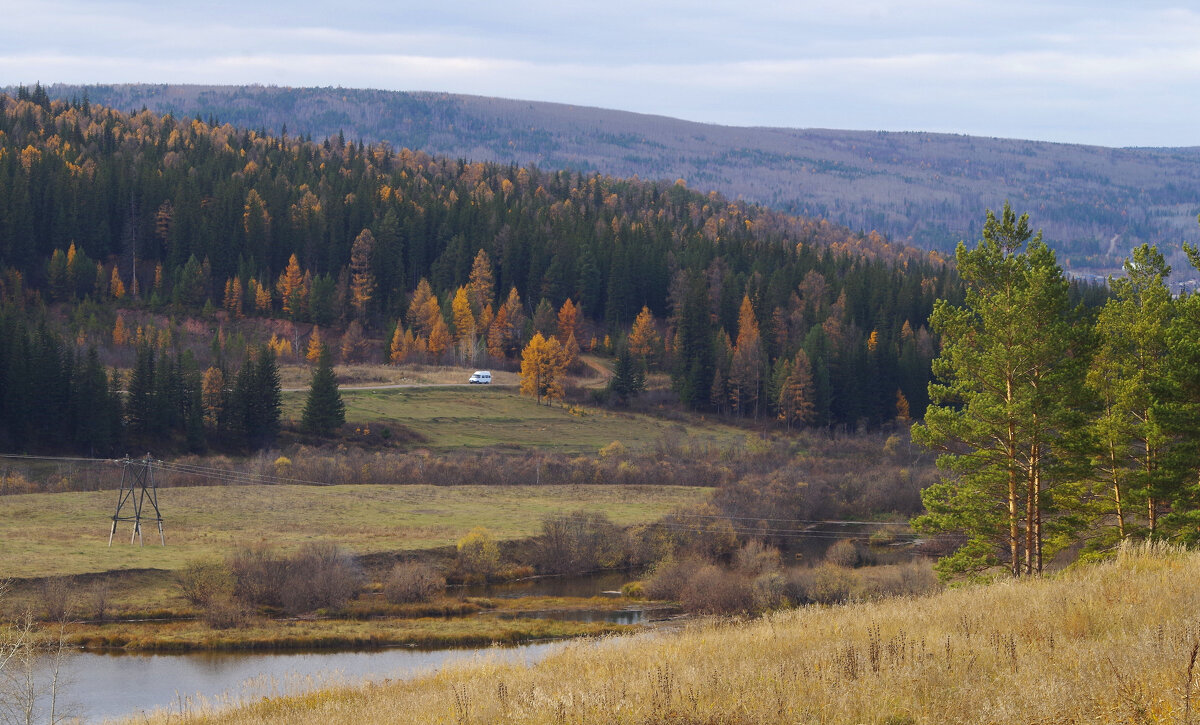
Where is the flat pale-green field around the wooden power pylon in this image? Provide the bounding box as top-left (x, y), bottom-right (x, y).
top-left (0, 485), bottom-right (708, 579)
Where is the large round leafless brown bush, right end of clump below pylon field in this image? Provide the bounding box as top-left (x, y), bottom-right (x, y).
top-left (281, 543), bottom-right (362, 615)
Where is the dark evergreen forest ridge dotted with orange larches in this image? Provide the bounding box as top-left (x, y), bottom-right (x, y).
top-left (0, 88), bottom-right (961, 448)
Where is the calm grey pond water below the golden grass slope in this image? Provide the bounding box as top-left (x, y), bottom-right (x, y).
top-left (31, 642), bottom-right (566, 723)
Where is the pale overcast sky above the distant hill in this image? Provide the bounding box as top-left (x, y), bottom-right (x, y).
top-left (0, 0), bottom-right (1200, 146)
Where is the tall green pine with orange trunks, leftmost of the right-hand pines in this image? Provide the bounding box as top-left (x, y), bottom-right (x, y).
top-left (912, 204), bottom-right (1082, 576)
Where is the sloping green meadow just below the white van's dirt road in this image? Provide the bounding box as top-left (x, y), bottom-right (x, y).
top-left (283, 385), bottom-right (745, 453)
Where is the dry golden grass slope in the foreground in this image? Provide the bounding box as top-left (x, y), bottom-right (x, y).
top-left (142, 549), bottom-right (1200, 725)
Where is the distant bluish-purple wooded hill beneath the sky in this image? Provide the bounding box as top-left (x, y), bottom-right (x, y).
top-left (25, 85), bottom-right (1200, 275)
